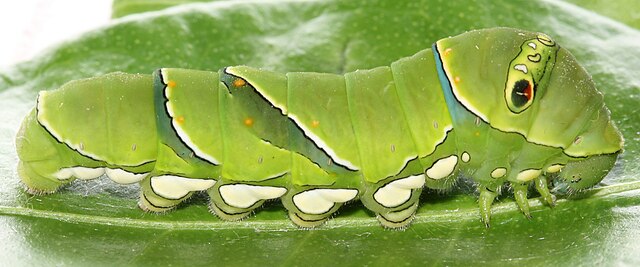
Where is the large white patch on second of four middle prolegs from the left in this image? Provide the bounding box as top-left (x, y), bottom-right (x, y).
top-left (219, 184), bottom-right (287, 209)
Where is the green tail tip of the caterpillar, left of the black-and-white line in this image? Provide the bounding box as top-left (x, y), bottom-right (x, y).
top-left (16, 109), bottom-right (73, 195)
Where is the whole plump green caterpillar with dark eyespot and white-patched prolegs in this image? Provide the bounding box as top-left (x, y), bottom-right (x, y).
top-left (16, 28), bottom-right (624, 228)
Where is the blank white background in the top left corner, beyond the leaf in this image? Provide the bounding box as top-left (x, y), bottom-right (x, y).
top-left (0, 0), bottom-right (112, 68)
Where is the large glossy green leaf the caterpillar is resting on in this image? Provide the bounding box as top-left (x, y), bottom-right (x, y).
top-left (0, 0), bottom-right (640, 266)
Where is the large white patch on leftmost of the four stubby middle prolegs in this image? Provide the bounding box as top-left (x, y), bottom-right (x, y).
top-left (151, 175), bottom-right (216, 199)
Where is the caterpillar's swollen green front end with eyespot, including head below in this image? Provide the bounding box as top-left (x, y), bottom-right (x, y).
top-left (434, 28), bottom-right (623, 189)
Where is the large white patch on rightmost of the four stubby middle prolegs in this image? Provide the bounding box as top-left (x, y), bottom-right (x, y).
top-left (373, 174), bottom-right (425, 208)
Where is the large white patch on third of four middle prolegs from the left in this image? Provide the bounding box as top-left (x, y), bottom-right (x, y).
top-left (293, 188), bottom-right (358, 214)
